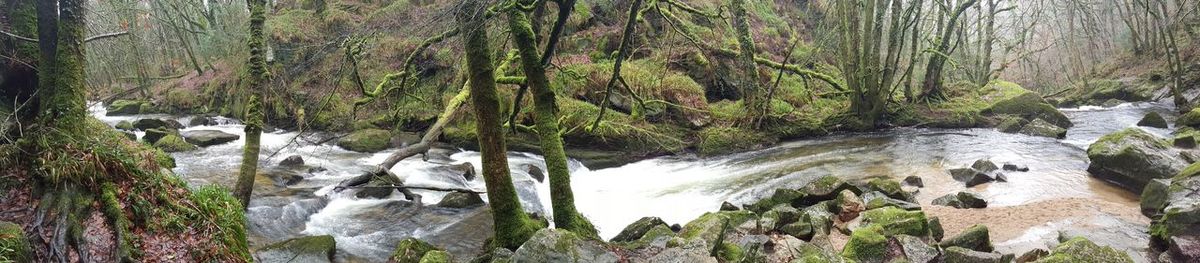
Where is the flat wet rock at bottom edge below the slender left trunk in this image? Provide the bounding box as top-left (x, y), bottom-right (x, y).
top-left (254, 235), bottom-right (337, 262)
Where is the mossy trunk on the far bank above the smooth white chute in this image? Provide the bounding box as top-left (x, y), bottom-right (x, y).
top-left (730, 0), bottom-right (770, 119)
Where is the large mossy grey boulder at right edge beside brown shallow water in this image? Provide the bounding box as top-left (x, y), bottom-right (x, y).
top-left (1087, 128), bottom-right (1188, 192)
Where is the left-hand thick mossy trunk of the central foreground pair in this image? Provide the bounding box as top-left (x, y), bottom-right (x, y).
top-left (456, 0), bottom-right (538, 249)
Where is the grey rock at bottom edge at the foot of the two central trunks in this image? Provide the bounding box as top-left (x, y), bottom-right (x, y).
top-left (512, 228), bottom-right (619, 262)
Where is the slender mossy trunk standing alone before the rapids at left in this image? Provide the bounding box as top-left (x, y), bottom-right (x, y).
top-left (234, 0), bottom-right (266, 208)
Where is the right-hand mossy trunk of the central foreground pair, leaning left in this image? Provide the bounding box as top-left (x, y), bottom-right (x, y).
top-left (509, 0), bottom-right (599, 238)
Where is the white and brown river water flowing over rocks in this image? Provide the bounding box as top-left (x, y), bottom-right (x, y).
top-left (91, 103), bottom-right (1175, 262)
